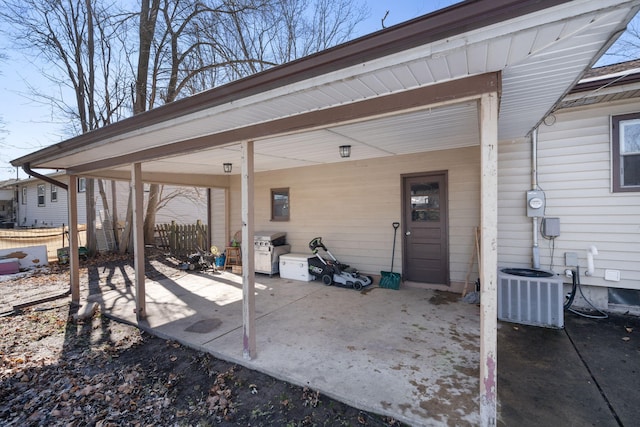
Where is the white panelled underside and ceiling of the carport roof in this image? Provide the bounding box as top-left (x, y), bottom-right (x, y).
top-left (14, 0), bottom-right (639, 182)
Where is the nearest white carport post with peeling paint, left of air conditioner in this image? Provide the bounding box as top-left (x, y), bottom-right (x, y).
top-left (480, 92), bottom-right (499, 427)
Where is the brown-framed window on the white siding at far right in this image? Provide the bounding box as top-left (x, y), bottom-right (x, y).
top-left (611, 113), bottom-right (640, 192)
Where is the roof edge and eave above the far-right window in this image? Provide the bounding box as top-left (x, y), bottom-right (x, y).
top-left (557, 59), bottom-right (640, 109)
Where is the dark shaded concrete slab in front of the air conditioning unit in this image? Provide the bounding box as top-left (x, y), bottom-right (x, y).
top-left (498, 313), bottom-right (640, 426)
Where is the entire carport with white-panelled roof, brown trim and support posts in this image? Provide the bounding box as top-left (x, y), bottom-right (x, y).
top-left (12, 0), bottom-right (638, 425)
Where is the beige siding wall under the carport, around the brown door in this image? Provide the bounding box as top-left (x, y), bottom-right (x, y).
top-left (230, 146), bottom-right (480, 285)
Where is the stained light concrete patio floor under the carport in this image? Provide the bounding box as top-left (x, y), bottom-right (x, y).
top-left (89, 272), bottom-right (480, 426)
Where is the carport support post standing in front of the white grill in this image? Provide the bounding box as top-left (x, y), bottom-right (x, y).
top-left (240, 141), bottom-right (256, 360)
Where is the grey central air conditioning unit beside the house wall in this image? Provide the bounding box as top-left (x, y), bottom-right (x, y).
top-left (498, 268), bottom-right (564, 328)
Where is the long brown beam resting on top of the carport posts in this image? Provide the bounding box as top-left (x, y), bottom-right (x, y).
top-left (68, 72), bottom-right (501, 174)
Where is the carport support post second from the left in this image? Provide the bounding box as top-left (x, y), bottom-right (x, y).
top-left (131, 163), bottom-right (147, 320)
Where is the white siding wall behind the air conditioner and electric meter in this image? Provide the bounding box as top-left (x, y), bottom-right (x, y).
top-left (498, 100), bottom-right (640, 289)
